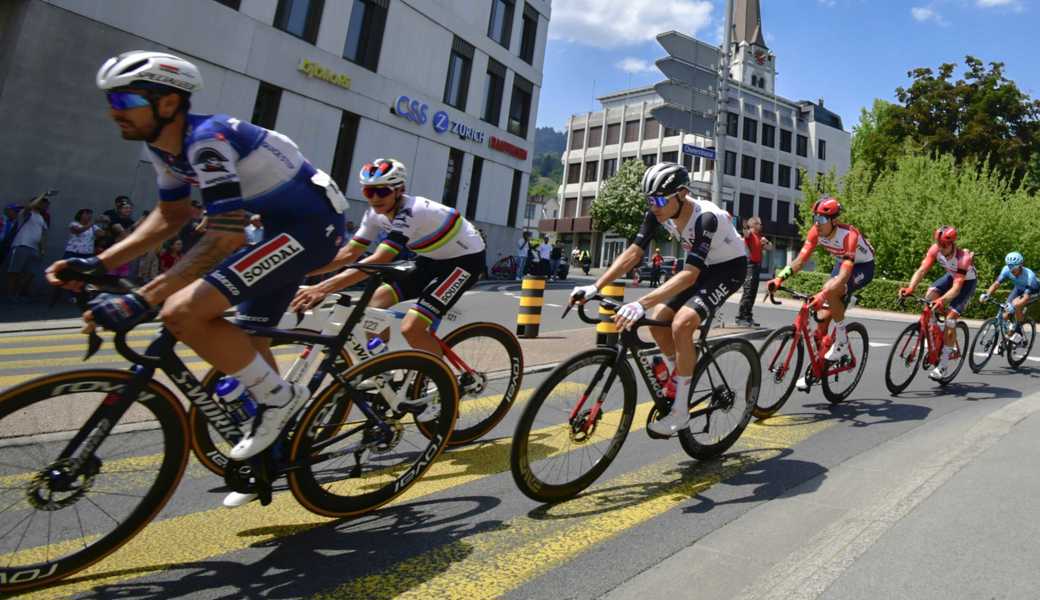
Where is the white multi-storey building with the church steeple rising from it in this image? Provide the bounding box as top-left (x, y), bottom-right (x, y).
top-left (540, 0), bottom-right (851, 268)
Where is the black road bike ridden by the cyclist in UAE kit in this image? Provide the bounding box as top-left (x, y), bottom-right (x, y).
top-left (510, 294), bottom-right (760, 502)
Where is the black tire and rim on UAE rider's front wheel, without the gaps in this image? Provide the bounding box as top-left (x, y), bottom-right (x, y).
top-left (510, 348), bottom-right (635, 503)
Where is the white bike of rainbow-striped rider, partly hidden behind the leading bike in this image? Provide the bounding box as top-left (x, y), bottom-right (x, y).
top-left (188, 294), bottom-right (523, 476)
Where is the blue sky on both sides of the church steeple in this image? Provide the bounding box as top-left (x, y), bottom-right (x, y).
top-left (538, 0), bottom-right (1040, 131)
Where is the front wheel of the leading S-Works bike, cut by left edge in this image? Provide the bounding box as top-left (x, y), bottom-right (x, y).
top-left (0, 369), bottom-right (188, 595)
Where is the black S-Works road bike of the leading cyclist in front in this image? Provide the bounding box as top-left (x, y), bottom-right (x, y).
top-left (0, 263), bottom-right (459, 594)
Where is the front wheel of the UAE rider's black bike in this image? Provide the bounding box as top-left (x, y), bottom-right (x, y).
top-left (510, 348), bottom-right (632, 502)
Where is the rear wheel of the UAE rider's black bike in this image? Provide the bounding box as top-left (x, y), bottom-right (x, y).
top-left (677, 339), bottom-right (761, 461)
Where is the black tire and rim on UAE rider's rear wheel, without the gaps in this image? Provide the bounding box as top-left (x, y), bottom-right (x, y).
top-left (679, 339), bottom-right (761, 461)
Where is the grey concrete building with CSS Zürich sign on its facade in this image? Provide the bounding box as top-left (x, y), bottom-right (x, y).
top-left (0, 0), bottom-right (550, 268)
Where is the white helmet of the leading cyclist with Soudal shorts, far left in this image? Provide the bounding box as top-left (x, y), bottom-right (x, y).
top-left (97, 50), bottom-right (202, 94)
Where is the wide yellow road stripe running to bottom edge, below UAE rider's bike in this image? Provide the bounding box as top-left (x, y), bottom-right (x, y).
top-left (315, 417), bottom-right (833, 600)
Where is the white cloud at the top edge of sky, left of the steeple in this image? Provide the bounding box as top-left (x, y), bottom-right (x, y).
top-left (549, 0), bottom-right (713, 48)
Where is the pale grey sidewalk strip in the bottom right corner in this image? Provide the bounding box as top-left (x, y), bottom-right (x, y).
top-left (606, 392), bottom-right (1040, 600)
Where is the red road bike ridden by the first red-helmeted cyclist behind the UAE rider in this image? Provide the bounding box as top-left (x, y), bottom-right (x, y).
top-left (755, 286), bottom-right (870, 419)
